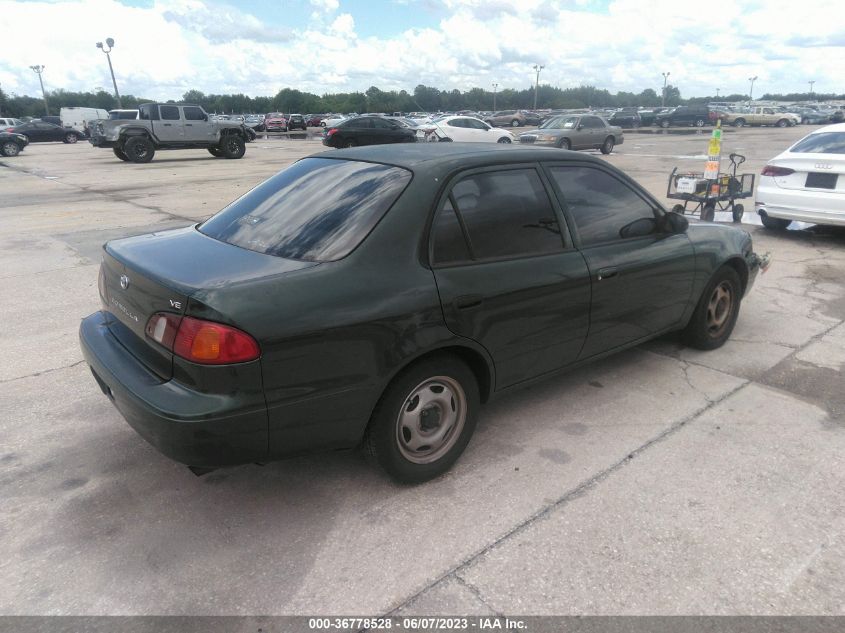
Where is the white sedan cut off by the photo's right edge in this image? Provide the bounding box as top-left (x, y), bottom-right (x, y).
top-left (757, 123), bottom-right (845, 229)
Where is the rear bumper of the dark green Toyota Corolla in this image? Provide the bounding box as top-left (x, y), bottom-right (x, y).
top-left (79, 312), bottom-right (268, 468)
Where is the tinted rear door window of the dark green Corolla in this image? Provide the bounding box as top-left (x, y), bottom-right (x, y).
top-left (434, 169), bottom-right (564, 263)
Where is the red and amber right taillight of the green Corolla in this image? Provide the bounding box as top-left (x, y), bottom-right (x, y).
top-left (146, 312), bottom-right (261, 365)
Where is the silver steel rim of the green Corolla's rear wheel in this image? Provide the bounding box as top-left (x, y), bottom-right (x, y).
top-left (396, 376), bottom-right (467, 464)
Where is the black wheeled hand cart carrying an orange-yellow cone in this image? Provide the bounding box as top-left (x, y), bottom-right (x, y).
top-left (666, 154), bottom-right (754, 222)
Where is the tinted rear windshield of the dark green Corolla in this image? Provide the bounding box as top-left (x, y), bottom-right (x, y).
top-left (199, 158), bottom-right (411, 262)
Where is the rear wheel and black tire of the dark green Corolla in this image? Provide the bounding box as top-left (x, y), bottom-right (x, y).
top-left (364, 355), bottom-right (480, 483)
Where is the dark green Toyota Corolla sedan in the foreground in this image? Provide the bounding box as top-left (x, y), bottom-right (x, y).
top-left (80, 143), bottom-right (762, 482)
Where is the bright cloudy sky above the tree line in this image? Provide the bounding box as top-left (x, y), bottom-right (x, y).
top-left (0, 0), bottom-right (845, 99)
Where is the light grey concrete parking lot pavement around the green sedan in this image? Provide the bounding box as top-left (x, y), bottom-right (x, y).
top-left (0, 126), bottom-right (845, 615)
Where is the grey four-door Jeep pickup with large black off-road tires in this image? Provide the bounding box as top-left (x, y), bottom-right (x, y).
top-left (89, 103), bottom-right (247, 163)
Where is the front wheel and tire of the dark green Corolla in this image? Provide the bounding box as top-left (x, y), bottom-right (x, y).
top-left (681, 266), bottom-right (742, 350)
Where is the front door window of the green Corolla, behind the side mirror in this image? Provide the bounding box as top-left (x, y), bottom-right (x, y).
top-left (549, 166), bottom-right (657, 246)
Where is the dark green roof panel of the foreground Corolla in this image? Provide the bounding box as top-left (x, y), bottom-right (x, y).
top-left (312, 143), bottom-right (606, 171)
